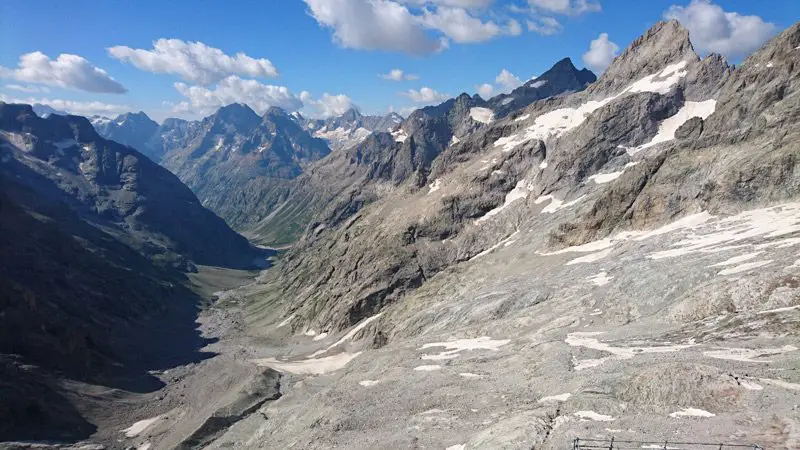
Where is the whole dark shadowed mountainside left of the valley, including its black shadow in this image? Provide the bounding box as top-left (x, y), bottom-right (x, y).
top-left (0, 103), bottom-right (263, 441)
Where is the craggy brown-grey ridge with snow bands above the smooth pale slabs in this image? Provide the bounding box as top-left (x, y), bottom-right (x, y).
top-left (252, 22), bottom-right (800, 342)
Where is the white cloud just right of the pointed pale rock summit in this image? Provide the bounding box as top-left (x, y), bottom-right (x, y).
top-left (664, 0), bottom-right (776, 59)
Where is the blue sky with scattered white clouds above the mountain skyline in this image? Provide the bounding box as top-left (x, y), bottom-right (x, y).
top-left (0, 0), bottom-right (800, 120)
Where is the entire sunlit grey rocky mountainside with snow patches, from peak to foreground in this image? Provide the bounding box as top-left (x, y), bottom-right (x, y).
top-left (162, 22), bottom-right (800, 449)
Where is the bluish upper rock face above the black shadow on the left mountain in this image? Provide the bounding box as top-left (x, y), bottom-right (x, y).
top-left (0, 104), bottom-right (256, 266)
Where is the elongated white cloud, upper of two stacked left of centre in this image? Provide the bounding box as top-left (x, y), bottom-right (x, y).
top-left (108, 39), bottom-right (278, 85)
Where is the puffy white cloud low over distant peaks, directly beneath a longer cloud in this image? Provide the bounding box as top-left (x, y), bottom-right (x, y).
top-left (175, 75), bottom-right (303, 115)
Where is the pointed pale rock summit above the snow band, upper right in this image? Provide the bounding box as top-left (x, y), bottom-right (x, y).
top-left (592, 19), bottom-right (700, 92)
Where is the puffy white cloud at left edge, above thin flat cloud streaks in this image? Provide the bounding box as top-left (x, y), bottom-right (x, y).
top-left (0, 52), bottom-right (128, 94)
